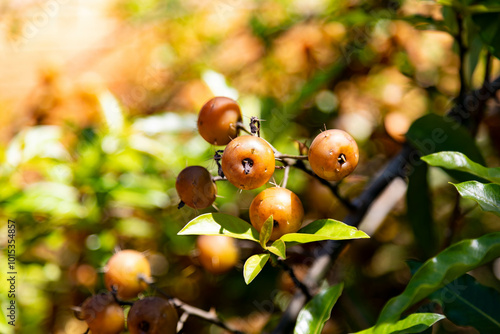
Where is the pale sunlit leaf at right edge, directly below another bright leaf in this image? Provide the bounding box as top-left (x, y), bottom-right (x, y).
top-left (452, 181), bottom-right (500, 216)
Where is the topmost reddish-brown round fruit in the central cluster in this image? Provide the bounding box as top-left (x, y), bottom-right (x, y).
top-left (198, 96), bottom-right (242, 145)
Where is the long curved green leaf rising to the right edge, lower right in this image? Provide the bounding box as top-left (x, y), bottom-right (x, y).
top-left (377, 232), bottom-right (500, 324)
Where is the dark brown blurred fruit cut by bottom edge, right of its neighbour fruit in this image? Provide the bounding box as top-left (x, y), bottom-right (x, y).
top-left (127, 297), bottom-right (179, 334)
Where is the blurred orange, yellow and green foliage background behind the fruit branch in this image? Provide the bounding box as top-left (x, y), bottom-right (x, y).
top-left (0, 0), bottom-right (500, 334)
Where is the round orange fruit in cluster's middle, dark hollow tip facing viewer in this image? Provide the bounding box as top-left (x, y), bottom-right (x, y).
top-left (221, 136), bottom-right (275, 190)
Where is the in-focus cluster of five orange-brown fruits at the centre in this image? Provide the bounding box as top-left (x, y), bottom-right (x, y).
top-left (176, 97), bottom-right (359, 245)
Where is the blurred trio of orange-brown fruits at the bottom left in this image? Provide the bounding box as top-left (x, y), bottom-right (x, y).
top-left (78, 250), bottom-right (178, 334)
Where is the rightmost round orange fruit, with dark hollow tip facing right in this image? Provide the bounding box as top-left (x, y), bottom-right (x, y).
top-left (308, 129), bottom-right (359, 181)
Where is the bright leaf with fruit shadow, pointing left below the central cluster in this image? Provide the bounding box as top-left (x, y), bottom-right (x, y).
top-left (177, 213), bottom-right (259, 242)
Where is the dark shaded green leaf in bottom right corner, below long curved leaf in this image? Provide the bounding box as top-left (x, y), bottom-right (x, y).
top-left (430, 275), bottom-right (500, 333)
